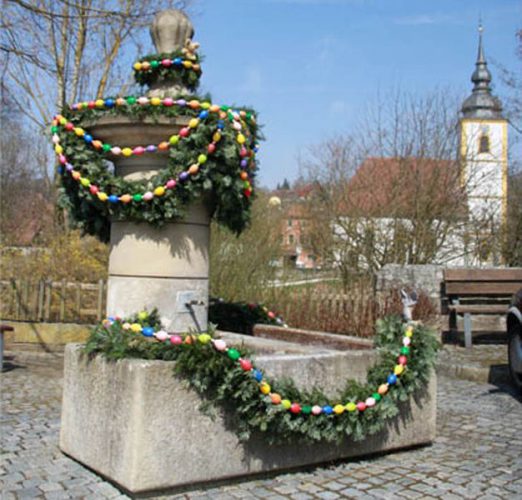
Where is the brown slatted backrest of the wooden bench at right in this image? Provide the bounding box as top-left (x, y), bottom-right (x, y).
top-left (444, 267), bottom-right (522, 297)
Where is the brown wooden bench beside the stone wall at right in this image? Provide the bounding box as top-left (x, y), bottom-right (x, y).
top-left (444, 268), bottom-right (522, 347)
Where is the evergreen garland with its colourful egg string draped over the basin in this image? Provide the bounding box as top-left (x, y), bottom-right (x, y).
top-left (85, 311), bottom-right (437, 444)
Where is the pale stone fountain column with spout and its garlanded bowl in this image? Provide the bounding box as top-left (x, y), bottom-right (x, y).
top-left (90, 116), bottom-right (210, 332)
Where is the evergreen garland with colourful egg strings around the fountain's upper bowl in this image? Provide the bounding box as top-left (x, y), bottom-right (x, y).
top-left (51, 96), bottom-right (258, 241)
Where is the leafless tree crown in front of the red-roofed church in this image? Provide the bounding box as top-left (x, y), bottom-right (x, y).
top-left (302, 90), bottom-right (504, 285)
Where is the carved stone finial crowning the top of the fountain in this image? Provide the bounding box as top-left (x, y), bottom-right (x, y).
top-left (150, 9), bottom-right (194, 53)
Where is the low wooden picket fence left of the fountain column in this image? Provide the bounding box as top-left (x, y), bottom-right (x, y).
top-left (0, 280), bottom-right (107, 324)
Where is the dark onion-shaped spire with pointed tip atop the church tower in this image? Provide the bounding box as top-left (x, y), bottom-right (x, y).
top-left (462, 26), bottom-right (502, 119)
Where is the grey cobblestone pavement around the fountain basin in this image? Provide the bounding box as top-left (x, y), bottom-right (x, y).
top-left (0, 355), bottom-right (522, 500)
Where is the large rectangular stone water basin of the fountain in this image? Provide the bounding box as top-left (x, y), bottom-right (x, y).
top-left (60, 333), bottom-right (436, 494)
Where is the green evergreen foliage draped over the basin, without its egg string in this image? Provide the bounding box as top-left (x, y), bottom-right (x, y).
top-left (85, 316), bottom-right (438, 443)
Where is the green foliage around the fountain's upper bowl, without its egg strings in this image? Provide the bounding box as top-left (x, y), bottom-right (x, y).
top-left (53, 96), bottom-right (259, 241)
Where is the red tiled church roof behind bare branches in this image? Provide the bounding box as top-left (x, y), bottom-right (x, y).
top-left (342, 157), bottom-right (466, 219)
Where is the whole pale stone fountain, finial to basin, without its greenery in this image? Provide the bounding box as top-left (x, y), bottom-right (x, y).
top-left (60, 11), bottom-right (436, 495)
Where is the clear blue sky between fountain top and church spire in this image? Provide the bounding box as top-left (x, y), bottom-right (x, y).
top-left (168, 0), bottom-right (522, 188)
